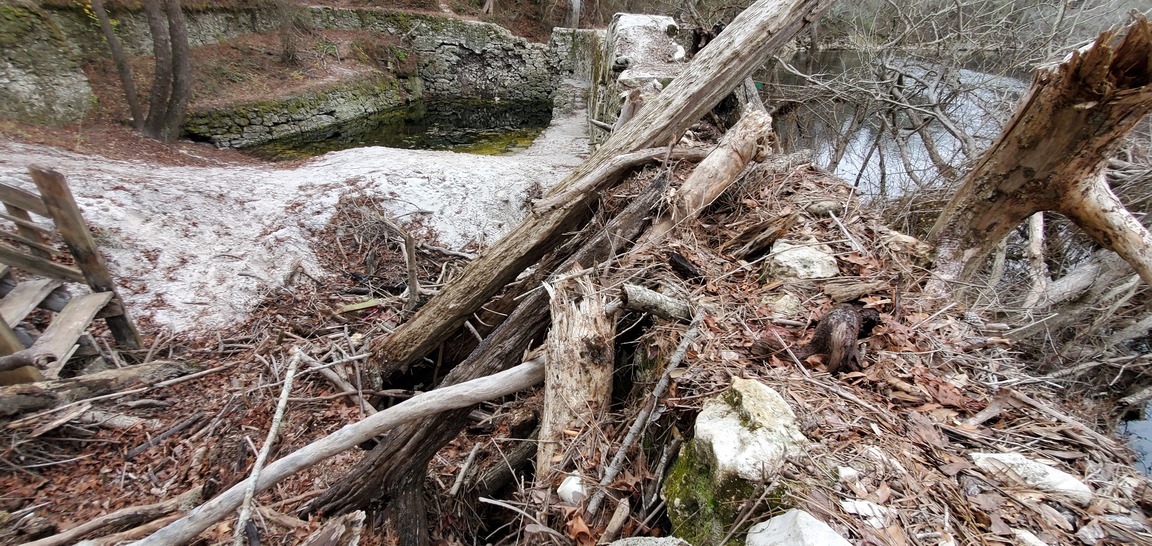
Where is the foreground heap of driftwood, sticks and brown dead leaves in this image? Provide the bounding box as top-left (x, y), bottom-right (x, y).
top-left (2, 106), bottom-right (1152, 545)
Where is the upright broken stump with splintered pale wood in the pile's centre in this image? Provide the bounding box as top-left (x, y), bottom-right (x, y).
top-left (536, 275), bottom-right (616, 485)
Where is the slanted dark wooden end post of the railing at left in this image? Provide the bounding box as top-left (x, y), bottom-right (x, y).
top-left (29, 165), bottom-right (141, 349)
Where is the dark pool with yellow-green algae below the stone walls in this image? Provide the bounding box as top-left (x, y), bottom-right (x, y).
top-left (244, 100), bottom-right (552, 160)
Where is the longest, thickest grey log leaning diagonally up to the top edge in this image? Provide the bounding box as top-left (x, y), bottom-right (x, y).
top-left (376, 0), bottom-right (832, 380)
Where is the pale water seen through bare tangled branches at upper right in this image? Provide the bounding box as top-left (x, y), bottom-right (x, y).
top-left (761, 51), bottom-right (1026, 198)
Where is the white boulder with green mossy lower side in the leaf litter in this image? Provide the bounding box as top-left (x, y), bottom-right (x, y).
top-left (661, 378), bottom-right (808, 545)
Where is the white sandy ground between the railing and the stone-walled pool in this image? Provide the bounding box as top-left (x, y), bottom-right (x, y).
top-left (0, 112), bottom-right (588, 333)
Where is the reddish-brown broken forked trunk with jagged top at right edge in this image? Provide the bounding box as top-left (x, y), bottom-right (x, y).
top-left (925, 18), bottom-right (1152, 296)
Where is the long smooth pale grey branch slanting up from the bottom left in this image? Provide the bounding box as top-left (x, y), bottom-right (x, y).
top-left (134, 359), bottom-right (544, 546)
